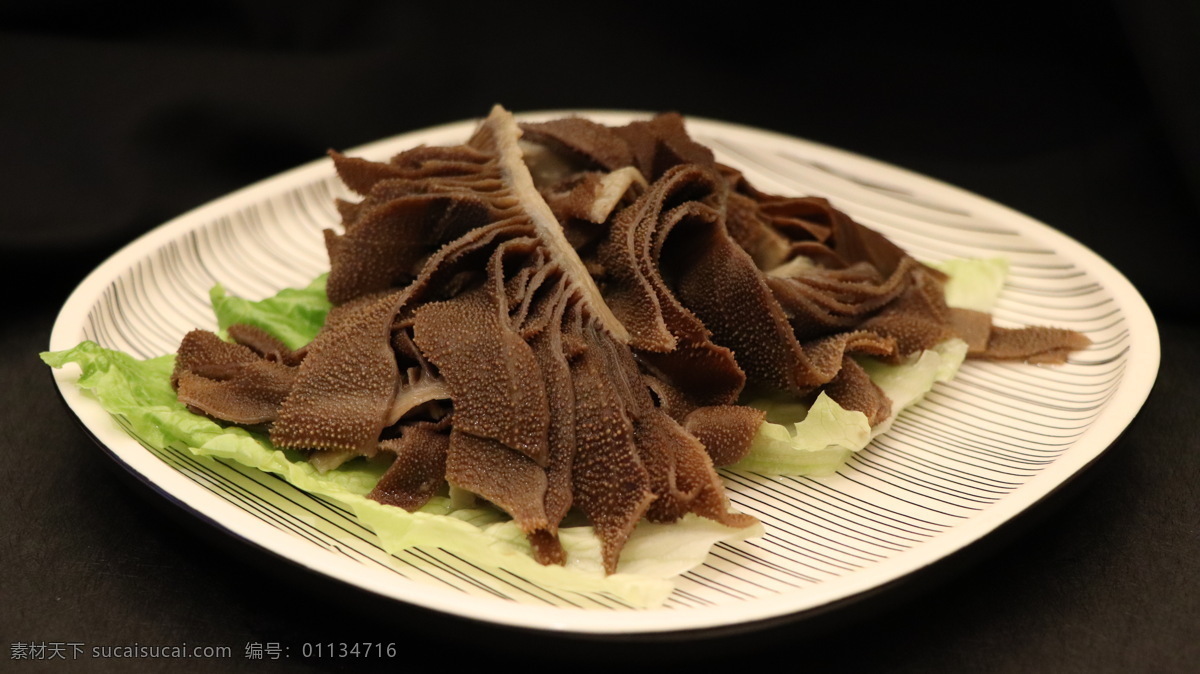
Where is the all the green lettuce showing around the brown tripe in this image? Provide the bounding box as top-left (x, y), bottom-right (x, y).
top-left (41, 260), bottom-right (1007, 607)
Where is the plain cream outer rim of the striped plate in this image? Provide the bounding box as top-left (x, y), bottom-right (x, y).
top-left (49, 109), bottom-right (1160, 636)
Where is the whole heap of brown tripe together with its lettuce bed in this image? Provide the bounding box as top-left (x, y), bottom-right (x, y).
top-left (47, 107), bottom-right (1088, 604)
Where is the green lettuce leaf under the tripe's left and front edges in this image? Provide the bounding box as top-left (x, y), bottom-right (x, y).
top-left (41, 302), bottom-right (762, 607)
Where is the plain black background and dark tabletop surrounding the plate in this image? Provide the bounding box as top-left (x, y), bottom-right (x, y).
top-left (0, 0), bottom-right (1200, 672)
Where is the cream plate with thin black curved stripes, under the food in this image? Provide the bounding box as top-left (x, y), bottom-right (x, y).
top-left (50, 112), bottom-right (1159, 634)
